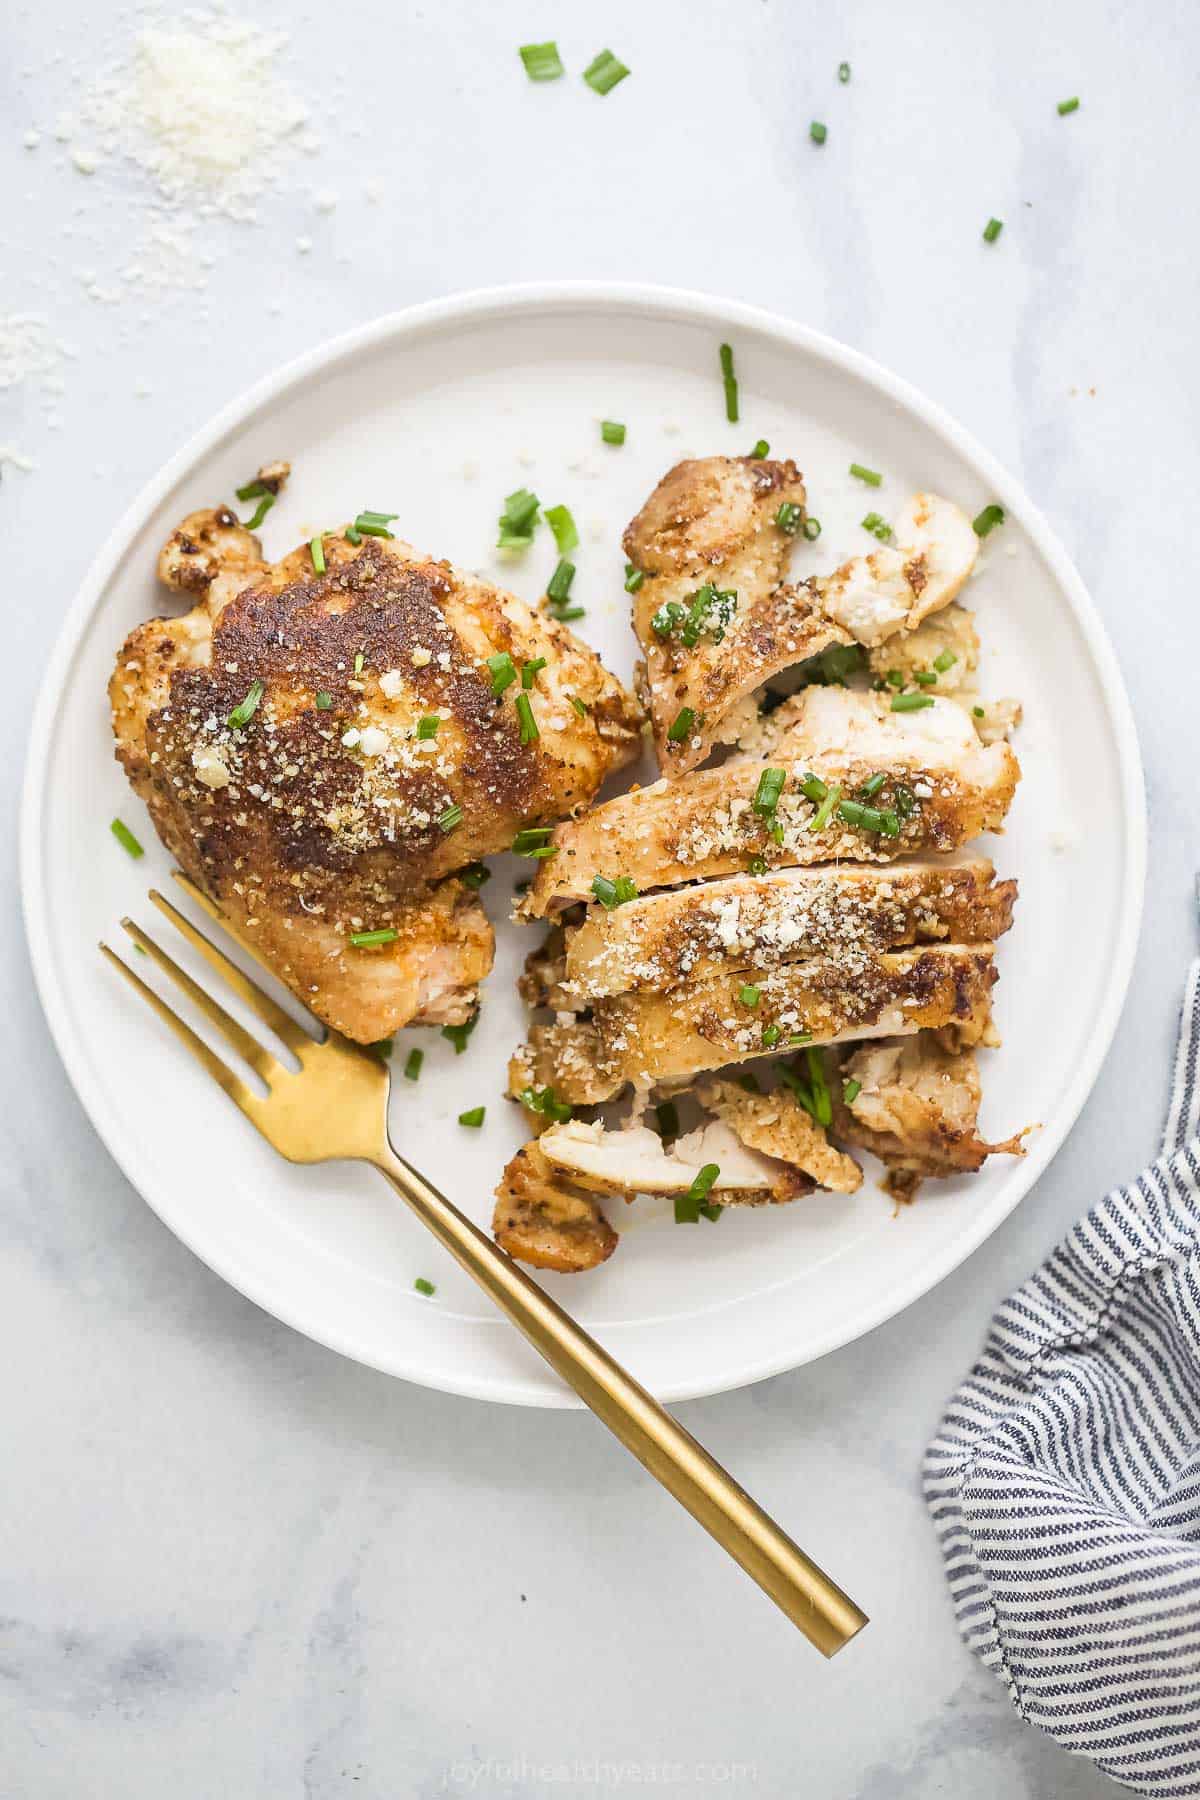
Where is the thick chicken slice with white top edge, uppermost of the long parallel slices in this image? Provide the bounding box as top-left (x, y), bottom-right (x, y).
top-left (520, 688), bottom-right (1020, 918)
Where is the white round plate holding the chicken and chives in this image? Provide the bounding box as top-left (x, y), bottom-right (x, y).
top-left (22, 284), bottom-right (1144, 1406)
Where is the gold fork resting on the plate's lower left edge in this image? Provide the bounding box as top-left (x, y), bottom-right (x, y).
top-left (101, 871), bottom-right (867, 1656)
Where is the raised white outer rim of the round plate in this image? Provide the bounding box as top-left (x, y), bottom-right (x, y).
top-left (18, 281), bottom-right (1148, 1408)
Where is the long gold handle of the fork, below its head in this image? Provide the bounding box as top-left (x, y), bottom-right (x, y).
top-left (372, 1148), bottom-right (867, 1656)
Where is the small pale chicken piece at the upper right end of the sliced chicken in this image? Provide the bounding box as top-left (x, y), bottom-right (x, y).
top-left (804, 493), bottom-right (979, 646)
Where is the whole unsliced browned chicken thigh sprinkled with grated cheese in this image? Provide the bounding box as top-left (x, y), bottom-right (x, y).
top-left (110, 493), bottom-right (639, 1042)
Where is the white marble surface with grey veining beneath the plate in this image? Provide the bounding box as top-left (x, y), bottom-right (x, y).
top-left (0, 0), bottom-right (1200, 1800)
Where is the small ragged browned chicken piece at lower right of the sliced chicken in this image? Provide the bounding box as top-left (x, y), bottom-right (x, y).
top-left (835, 1031), bottom-right (1029, 1201)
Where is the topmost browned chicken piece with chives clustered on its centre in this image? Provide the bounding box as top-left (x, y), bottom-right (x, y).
top-left (624, 455), bottom-right (849, 774)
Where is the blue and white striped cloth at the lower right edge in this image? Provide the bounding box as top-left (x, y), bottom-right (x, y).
top-left (925, 963), bottom-right (1200, 1796)
